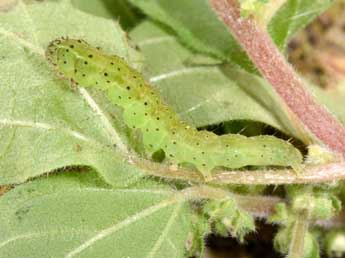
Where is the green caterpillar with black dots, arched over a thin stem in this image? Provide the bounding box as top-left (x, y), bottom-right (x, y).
top-left (46, 39), bottom-right (302, 178)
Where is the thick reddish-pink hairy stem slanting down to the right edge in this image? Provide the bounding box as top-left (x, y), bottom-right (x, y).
top-left (210, 0), bottom-right (345, 156)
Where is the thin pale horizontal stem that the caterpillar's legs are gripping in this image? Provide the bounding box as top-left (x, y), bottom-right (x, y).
top-left (134, 157), bottom-right (345, 185)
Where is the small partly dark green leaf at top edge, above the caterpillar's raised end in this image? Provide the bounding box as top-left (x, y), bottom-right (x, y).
top-left (72, 0), bottom-right (140, 29)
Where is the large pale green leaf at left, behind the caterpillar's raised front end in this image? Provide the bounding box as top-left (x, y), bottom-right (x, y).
top-left (0, 1), bottom-right (141, 184)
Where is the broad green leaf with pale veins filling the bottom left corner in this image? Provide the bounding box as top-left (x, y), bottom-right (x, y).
top-left (0, 170), bottom-right (192, 258)
